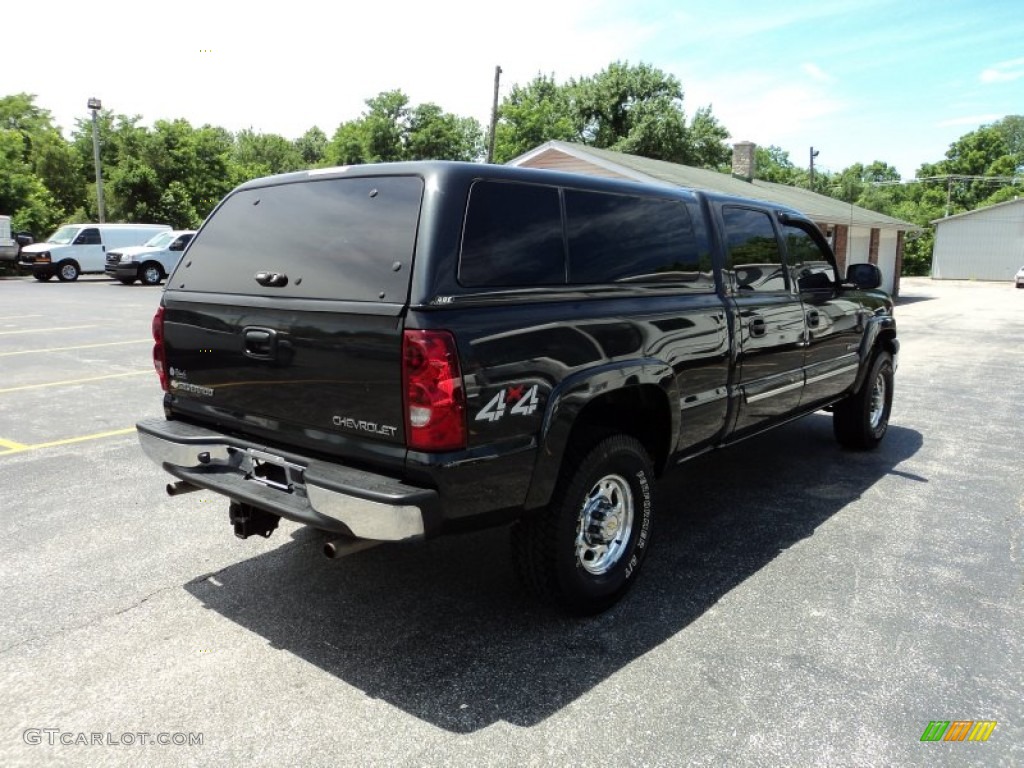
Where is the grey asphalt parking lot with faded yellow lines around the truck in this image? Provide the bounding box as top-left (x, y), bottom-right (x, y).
top-left (0, 278), bottom-right (1024, 766)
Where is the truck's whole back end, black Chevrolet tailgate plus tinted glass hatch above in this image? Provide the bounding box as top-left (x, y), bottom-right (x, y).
top-left (164, 176), bottom-right (423, 458)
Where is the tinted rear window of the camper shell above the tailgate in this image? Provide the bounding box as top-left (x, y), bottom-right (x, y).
top-left (169, 176), bottom-right (424, 302)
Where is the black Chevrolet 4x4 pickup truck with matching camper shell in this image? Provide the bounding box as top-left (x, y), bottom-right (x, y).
top-left (137, 163), bottom-right (899, 613)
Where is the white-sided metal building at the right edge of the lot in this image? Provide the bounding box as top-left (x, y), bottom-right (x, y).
top-left (932, 200), bottom-right (1024, 281)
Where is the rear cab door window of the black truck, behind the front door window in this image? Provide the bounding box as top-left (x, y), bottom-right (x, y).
top-left (722, 206), bottom-right (788, 292)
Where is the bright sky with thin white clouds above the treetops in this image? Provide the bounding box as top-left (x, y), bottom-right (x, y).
top-left (0, 0), bottom-right (1024, 178)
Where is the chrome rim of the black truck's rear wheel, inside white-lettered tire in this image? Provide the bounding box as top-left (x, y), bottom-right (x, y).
top-left (575, 475), bottom-right (635, 575)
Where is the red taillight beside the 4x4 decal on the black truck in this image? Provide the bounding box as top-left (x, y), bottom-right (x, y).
top-left (401, 331), bottom-right (466, 451)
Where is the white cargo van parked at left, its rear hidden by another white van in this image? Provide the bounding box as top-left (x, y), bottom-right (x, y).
top-left (17, 224), bottom-right (171, 283)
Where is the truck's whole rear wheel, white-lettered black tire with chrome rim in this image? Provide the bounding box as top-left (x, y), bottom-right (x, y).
top-left (512, 435), bottom-right (655, 615)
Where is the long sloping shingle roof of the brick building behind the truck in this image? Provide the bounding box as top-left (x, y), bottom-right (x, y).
top-left (509, 141), bottom-right (921, 231)
